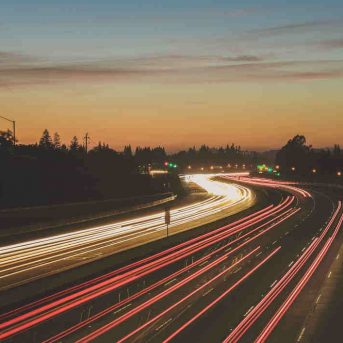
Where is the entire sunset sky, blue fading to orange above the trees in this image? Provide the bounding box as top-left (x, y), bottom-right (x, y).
top-left (0, 0), bottom-right (343, 151)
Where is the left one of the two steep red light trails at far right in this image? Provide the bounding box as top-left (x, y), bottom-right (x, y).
top-left (223, 202), bottom-right (342, 343)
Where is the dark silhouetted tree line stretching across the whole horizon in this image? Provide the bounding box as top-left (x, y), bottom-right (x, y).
top-left (0, 130), bottom-right (343, 207)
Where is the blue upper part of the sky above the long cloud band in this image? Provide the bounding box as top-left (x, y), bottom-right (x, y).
top-left (0, 0), bottom-right (343, 60)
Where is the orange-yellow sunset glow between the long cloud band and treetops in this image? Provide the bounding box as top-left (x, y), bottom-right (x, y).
top-left (0, 81), bottom-right (343, 151)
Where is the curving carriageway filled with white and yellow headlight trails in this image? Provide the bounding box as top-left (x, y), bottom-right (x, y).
top-left (0, 175), bottom-right (253, 290)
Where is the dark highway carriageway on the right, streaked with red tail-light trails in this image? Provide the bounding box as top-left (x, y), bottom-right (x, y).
top-left (0, 175), bottom-right (343, 343)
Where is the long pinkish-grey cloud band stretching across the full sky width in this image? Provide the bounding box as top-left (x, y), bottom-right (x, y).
top-left (0, 52), bottom-right (343, 87)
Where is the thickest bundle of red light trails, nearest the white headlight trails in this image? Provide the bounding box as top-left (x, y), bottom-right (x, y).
top-left (0, 197), bottom-right (294, 339)
